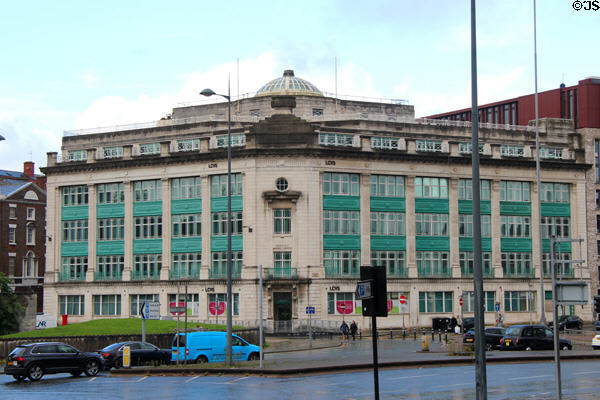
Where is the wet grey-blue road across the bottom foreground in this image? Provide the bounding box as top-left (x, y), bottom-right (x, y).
top-left (0, 361), bottom-right (600, 400)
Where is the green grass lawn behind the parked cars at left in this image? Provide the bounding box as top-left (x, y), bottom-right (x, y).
top-left (0, 318), bottom-right (226, 338)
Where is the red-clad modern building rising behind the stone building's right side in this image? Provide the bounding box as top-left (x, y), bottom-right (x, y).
top-left (427, 77), bottom-right (600, 128)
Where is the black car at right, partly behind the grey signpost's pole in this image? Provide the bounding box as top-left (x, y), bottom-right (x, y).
top-left (500, 325), bottom-right (573, 350)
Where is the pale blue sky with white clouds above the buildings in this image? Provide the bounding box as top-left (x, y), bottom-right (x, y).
top-left (0, 0), bottom-right (600, 172)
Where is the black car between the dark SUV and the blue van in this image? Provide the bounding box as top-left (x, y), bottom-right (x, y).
top-left (98, 342), bottom-right (171, 369)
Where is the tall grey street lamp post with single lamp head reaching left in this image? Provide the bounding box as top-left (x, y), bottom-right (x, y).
top-left (200, 79), bottom-right (233, 366)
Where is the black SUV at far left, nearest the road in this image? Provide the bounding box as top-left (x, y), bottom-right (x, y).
top-left (4, 342), bottom-right (104, 381)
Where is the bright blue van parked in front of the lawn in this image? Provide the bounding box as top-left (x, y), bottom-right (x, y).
top-left (171, 332), bottom-right (260, 363)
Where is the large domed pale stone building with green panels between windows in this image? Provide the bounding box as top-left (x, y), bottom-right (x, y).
top-left (44, 71), bottom-right (590, 327)
